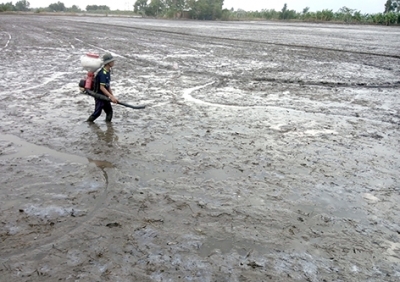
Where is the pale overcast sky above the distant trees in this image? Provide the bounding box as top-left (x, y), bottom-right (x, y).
top-left (27, 0), bottom-right (386, 14)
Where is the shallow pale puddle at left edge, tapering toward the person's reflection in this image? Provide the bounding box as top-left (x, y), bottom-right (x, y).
top-left (0, 133), bottom-right (89, 164)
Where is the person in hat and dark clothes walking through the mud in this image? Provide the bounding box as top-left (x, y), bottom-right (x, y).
top-left (87, 53), bottom-right (118, 122)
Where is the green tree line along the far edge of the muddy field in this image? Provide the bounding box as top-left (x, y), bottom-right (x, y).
top-left (0, 0), bottom-right (400, 25)
